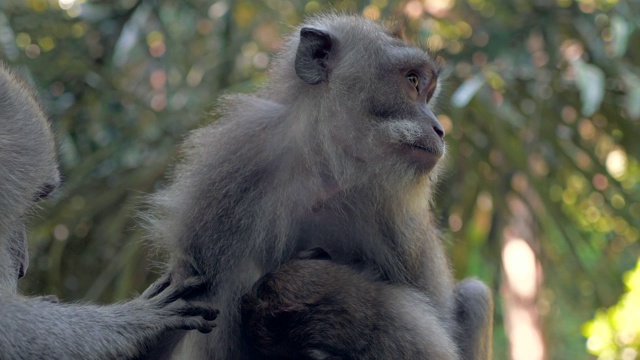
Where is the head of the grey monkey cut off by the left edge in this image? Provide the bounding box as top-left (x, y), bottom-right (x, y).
top-left (0, 63), bottom-right (60, 285)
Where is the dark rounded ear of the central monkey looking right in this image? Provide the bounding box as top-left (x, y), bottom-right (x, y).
top-left (295, 27), bottom-right (333, 85)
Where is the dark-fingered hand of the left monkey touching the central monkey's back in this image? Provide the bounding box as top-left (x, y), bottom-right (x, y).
top-left (134, 274), bottom-right (220, 333)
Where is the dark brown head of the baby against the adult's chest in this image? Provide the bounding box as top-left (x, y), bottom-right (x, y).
top-left (241, 248), bottom-right (370, 360)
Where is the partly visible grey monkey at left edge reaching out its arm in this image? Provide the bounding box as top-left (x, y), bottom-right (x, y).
top-left (0, 63), bottom-right (217, 360)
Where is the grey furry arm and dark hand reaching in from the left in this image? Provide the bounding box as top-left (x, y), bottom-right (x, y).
top-left (0, 278), bottom-right (218, 360)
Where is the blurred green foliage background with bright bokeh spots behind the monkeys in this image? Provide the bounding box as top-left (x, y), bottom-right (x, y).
top-left (0, 0), bottom-right (640, 360)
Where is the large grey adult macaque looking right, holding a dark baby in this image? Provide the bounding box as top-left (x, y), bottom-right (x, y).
top-left (146, 15), bottom-right (492, 360)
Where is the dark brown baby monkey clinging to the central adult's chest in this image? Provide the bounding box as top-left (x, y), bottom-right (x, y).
top-left (242, 248), bottom-right (459, 360)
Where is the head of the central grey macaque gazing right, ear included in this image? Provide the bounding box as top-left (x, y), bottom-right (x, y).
top-left (295, 19), bottom-right (445, 175)
